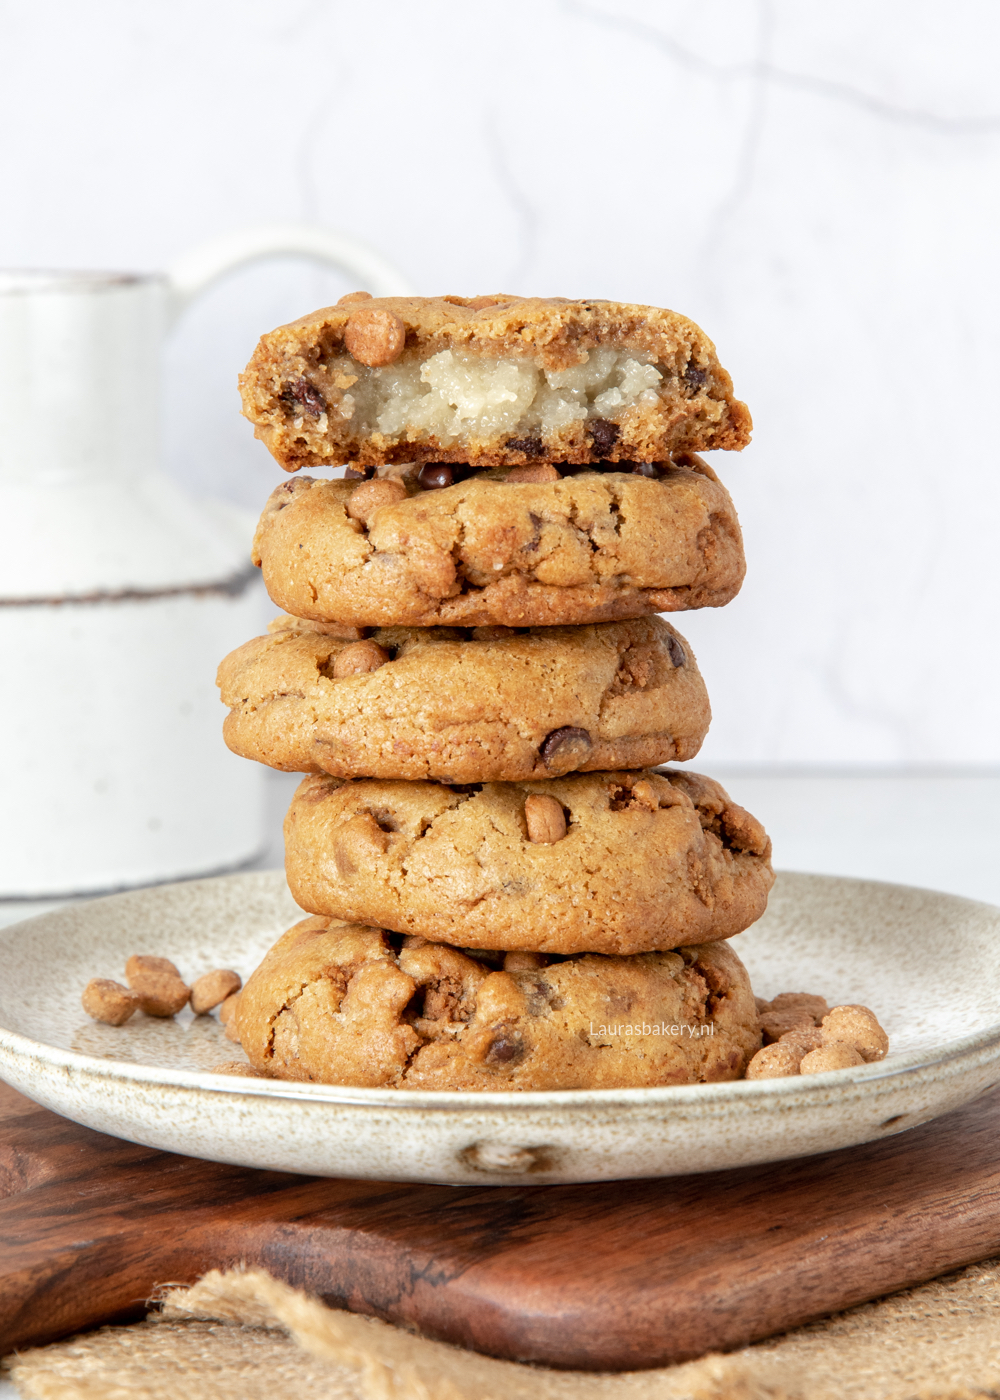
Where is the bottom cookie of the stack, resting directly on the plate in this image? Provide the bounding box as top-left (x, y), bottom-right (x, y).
top-left (235, 918), bottom-right (761, 1091)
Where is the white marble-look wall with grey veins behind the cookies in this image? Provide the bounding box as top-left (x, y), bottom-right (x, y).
top-left (0, 0), bottom-right (1000, 769)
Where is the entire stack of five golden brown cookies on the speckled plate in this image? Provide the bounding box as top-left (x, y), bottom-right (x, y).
top-left (218, 293), bottom-right (773, 1089)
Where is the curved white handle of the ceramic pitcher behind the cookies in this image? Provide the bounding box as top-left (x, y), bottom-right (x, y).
top-left (167, 224), bottom-right (413, 325)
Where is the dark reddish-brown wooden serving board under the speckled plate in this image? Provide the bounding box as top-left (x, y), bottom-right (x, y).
top-left (0, 1085), bottom-right (1000, 1371)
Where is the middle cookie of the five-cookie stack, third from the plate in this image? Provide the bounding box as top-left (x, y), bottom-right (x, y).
top-left (218, 617), bottom-right (711, 783)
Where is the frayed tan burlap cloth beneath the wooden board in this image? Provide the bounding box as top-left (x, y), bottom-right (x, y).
top-left (4, 1260), bottom-right (1000, 1400)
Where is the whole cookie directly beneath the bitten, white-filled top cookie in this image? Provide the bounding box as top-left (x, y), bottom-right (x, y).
top-left (254, 456), bottom-right (745, 627)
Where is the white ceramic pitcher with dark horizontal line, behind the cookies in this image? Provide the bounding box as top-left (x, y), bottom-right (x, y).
top-left (0, 225), bottom-right (409, 900)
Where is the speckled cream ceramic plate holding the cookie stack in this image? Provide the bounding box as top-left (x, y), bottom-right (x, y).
top-left (0, 874), bottom-right (1000, 1184)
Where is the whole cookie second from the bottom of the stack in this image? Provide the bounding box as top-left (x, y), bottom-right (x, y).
top-left (284, 770), bottom-right (775, 955)
